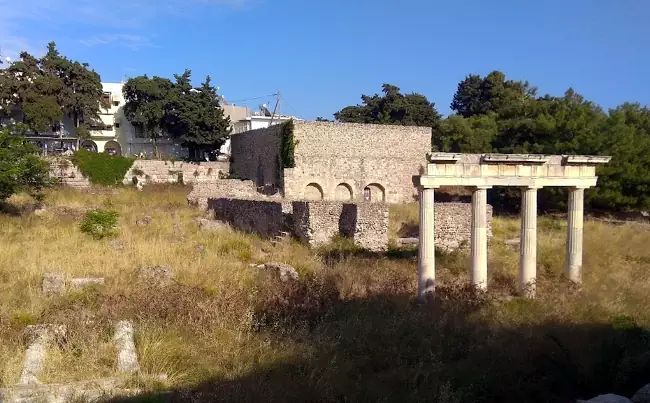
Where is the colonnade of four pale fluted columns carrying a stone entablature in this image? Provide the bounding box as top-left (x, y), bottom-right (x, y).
top-left (418, 153), bottom-right (611, 299)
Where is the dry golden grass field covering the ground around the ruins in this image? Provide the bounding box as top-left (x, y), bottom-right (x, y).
top-left (0, 186), bottom-right (650, 402)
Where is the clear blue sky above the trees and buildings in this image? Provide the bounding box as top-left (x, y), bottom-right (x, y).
top-left (0, 0), bottom-right (650, 119)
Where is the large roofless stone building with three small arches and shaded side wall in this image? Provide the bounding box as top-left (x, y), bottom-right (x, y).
top-left (230, 122), bottom-right (431, 203)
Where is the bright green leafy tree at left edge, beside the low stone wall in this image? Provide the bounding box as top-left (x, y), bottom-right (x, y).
top-left (0, 128), bottom-right (51, 201)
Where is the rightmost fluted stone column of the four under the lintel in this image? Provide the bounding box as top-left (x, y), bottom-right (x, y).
top-left (565, 188), bottom-right (585, 284)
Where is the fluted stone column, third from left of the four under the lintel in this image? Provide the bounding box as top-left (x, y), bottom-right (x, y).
top-left (519, 187), bottom-right (537, 298)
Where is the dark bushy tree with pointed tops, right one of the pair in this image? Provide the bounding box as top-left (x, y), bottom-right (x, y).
top-left (165, 70), bottom-right (230, 160)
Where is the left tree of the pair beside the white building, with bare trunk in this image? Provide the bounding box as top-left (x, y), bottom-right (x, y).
top-left (122, 75), bottom-right (172, 158)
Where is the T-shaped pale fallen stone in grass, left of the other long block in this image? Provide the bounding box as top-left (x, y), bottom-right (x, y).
top-left (18, 325), bottom-right (65, 385)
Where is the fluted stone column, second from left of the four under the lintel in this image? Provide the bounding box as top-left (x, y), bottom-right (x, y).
top-left (469, 187), bottom-right (488, 290)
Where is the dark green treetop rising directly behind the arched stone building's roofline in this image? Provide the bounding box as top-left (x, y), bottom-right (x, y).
top-left (334, 84), bottom-right (440, 127)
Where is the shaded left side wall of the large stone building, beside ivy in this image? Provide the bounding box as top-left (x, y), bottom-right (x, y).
top-left (230, 125), bottom-right (282, 187)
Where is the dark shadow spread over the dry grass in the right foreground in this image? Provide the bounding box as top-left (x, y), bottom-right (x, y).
top-left (106, 281), bottom-right (650, 403)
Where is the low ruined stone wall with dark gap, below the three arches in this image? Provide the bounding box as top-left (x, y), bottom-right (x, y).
top-left (293, 201), bottom-right (388, 251)
